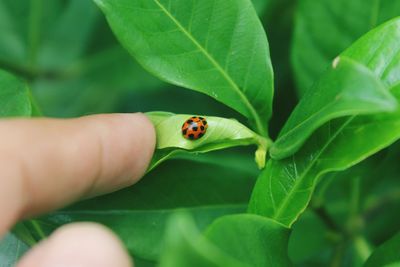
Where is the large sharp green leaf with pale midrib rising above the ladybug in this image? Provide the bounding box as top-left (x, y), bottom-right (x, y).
top-left (95, 0), bottom-right (273, 135)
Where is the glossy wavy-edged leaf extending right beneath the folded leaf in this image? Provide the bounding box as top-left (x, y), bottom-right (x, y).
top-left (250, 82), bottom-right (400, 226)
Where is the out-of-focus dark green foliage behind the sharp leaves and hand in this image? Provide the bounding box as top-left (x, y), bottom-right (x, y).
top-left (0, 0), bottom-right (400, 267)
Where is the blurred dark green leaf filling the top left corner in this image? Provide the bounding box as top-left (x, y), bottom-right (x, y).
top-left (0, 0), bottom-right (98, 72)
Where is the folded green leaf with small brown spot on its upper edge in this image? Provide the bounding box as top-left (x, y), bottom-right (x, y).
top-left (270, 57), bottom-right (397, 159)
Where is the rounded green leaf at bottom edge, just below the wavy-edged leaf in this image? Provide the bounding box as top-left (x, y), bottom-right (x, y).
top-left (205, 214), bottom-right (291, 267)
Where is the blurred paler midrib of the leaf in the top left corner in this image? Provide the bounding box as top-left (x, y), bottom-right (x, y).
top-left (28, 0), bottom-right (43, 70)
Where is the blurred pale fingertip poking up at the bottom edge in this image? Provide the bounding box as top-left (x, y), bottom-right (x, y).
top-left (17, 223), bottom-right (133, 267)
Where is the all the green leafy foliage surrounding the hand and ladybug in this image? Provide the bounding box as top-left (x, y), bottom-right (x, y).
top-left (0, 0), bottom-right (400, 266)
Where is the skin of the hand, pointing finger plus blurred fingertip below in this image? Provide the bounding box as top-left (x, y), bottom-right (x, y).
top-left (0, 113), bottom-right (155, 267)
